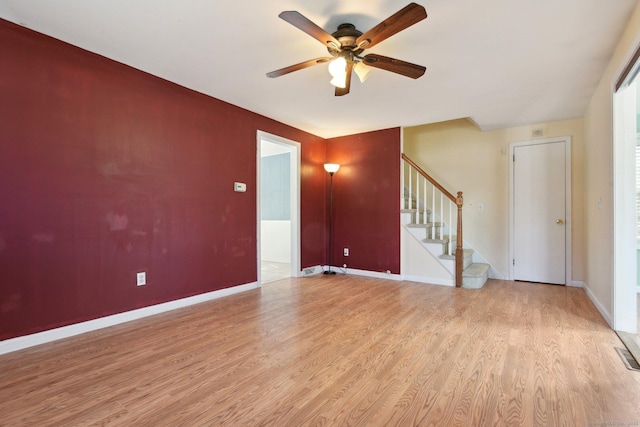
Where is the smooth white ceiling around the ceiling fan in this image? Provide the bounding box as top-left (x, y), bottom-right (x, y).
top-left (0, 0), bottom-right (636, 138)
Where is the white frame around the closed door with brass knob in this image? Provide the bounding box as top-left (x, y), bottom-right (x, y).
top-left (508, 136), bottom-right (573, 286)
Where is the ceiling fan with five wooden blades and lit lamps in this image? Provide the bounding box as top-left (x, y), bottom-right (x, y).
top-left (267, 3), bottom-right (427, 96)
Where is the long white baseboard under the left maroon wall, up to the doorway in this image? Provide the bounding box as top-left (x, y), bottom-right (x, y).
top-left (0, 282), bottom-right (258, 354)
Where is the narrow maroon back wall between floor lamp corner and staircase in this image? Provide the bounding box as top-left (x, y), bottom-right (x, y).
top-left (327, 128), bottom-right (400, 274)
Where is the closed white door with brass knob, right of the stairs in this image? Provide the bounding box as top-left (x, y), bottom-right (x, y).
top-left (512, 140), bottom-right (568, 284)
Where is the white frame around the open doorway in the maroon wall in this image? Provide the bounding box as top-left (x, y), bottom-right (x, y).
top-left (256, 130), bottom-right (302, 286)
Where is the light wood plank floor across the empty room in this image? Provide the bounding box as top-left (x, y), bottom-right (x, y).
top-left (0, 275), bottom-right (640, 426)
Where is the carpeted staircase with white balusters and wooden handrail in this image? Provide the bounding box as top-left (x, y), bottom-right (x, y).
top-left (400, 154), bottom-right (489, 289)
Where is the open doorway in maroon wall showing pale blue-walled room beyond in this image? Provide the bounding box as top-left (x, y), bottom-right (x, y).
top-left (256, 131), bottom-right (300, 285)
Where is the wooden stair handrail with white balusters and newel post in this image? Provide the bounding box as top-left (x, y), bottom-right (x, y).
top-left (402, 153), bottom-right (464, 288)
